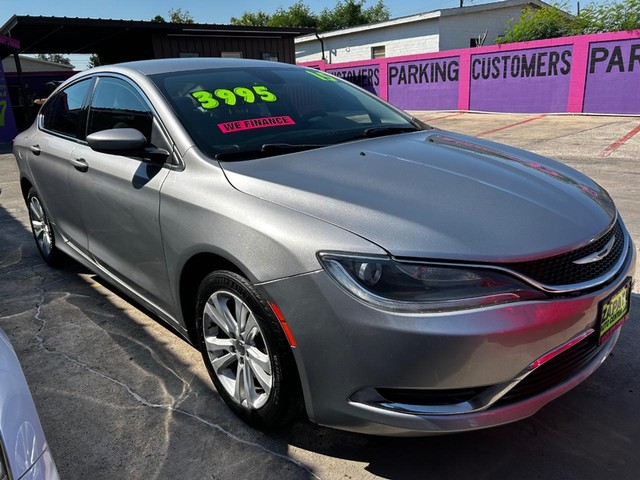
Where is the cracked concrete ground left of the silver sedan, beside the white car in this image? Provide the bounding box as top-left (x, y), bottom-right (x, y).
top-left (0, 197), bottom-right (313, 479)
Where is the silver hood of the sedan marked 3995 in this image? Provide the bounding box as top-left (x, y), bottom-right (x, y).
top-left (222, 130), bottom-right (616, 261)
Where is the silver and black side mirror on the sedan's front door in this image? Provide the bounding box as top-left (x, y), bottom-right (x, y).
top-left (87, 128), bottom-right (169, 163)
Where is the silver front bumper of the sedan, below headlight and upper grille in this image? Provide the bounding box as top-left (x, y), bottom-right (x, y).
top-left (263, 242), bottom-right (636, 435)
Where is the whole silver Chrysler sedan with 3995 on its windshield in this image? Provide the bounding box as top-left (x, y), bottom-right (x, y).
top-left (14, 59), bottom-right (635, 435)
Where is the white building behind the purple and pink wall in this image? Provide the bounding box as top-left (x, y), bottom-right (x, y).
top-left (295, 0), bottom-right (546, 63)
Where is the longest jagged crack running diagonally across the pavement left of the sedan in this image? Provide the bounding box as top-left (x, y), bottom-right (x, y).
top-left (34, 288), bottom-right (320, 480)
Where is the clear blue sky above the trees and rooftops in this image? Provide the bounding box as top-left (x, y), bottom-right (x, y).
top-left (0, 0), bottom-right (590, 70)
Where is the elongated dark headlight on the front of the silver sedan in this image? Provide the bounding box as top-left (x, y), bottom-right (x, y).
top-left (319, 253), bottom-right (545, 313)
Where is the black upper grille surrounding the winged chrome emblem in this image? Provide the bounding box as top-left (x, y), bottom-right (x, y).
top-left (503, 220), bottom-right (625, 286)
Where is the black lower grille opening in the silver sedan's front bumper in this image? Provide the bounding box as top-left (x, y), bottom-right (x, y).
top-left (495, 335), bottom-right (606, 406)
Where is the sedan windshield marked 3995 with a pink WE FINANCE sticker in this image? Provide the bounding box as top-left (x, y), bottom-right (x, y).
top-left (151, 65), bottom-right (424, 160)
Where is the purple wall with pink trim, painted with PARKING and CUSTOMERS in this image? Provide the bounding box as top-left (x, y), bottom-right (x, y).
top-left (303, 30), bottom-right (640, 114)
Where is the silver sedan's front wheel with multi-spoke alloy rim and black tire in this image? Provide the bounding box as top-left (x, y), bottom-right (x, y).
top-left (196, 271), bottom-right (302, 428)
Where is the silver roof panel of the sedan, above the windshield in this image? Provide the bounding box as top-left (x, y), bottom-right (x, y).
top-left (95, 57), bottom-right (293, 75)
